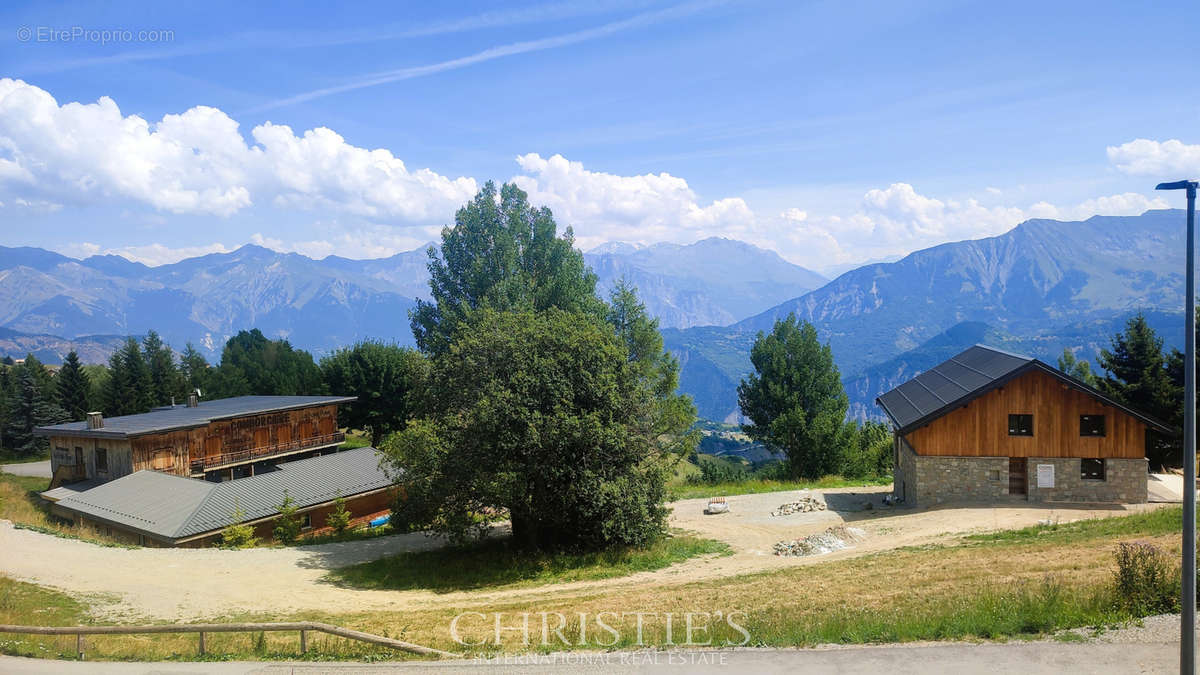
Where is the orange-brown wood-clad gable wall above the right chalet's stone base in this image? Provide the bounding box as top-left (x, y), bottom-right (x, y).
top-left (904, 370), bottom-right (1147, 459)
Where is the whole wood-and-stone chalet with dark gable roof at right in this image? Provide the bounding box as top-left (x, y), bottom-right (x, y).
top-left (876, 345), bottom-right (1171, 504)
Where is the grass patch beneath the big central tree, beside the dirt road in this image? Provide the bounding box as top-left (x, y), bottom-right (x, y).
top-left (330, 536), bottom-right (730, 592)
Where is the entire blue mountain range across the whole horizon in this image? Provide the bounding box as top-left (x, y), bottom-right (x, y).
top-left (0, 210), bottom-right (1183, 420)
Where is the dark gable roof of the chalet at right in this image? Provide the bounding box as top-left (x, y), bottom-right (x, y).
top-left (875, 345), bottom-right (1171, 434)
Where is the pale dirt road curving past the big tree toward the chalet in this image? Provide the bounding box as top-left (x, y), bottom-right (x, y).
top-left (0, 488), bottom-right (1159, 620)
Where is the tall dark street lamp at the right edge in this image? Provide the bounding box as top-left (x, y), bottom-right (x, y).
top-left (1154, 180), bottom-right (1196, 675)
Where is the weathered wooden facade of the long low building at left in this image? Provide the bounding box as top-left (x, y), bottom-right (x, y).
top-left (50, 404), bottom-right (346, 485)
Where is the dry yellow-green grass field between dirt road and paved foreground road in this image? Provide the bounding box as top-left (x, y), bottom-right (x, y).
top-left (0, 508), bottom-right (1181, 659)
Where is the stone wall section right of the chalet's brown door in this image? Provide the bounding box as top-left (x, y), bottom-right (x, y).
top-left (1028, 458), bottom-right (1148, 503)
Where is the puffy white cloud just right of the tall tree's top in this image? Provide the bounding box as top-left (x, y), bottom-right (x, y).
top-left (512, 153), bottom-right (754, 249)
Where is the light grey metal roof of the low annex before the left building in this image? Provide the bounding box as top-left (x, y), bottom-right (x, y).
top-left (48, 447), bottom-right (391, 539)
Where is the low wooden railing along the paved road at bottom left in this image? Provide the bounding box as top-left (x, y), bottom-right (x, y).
top-left (0, 621), bottom-right (462, 661)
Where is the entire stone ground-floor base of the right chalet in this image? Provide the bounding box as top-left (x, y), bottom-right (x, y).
top-left (893, 438), bottom-right (1148, 506)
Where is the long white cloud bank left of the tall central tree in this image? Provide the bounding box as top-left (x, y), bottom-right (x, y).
top-left (0, 78), bottom-right (476, 218)
